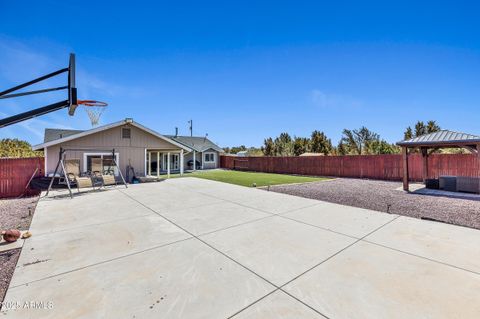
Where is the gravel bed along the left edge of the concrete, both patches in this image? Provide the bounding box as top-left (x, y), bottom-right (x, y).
top-left (0, 196), bottom-right (39, 308)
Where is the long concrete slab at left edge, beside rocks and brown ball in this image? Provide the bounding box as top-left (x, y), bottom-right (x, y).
top-left (10, 215), bottom-right (191, 287)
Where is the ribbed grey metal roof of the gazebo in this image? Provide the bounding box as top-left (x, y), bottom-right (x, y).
top-left (397, 130), bottom-right (480, 147)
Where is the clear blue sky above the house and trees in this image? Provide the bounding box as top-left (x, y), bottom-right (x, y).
top-left (0, 0), bottom-right (480, 146)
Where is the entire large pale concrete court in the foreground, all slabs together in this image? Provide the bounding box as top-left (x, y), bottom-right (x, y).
top-left (0, 178), bottom-right (480, 319)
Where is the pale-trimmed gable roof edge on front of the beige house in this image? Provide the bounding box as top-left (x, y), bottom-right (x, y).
top-left (32, 119), bottom-right (191, 152)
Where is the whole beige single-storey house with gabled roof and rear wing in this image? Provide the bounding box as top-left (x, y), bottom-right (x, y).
top-left (33, 119), bottom-right (222, 176)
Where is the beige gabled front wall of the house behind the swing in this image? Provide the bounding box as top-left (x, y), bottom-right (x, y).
top-left (46, 123), bottom-right (180, 176)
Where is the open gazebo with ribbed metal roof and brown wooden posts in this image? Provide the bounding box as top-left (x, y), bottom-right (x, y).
top-left (397, 130), bottom-right (480, 191)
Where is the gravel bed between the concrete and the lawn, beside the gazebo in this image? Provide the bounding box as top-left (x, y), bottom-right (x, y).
top-left (270, 178), bottom-right (480, 229)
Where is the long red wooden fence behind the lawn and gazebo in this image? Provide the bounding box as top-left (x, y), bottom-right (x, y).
top-left (220, 154), bottom-right (480, 181)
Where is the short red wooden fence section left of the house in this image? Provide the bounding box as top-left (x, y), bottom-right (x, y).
top-left (0, 157), bottom-right (44, 198)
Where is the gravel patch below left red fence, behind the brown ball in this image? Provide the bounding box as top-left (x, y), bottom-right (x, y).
top-left (0, 196), bottom-right (39, 230)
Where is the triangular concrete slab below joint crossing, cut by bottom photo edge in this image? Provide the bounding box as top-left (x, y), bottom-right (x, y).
top-left (233, 290), bottom-right (325, 319)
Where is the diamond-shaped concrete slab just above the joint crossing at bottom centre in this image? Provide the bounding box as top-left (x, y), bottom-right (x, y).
top-left (201, 216), bottom-right (355, 286)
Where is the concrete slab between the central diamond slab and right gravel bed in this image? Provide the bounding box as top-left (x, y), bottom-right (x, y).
top-left (282, 201), bottom-right (397, 238)
